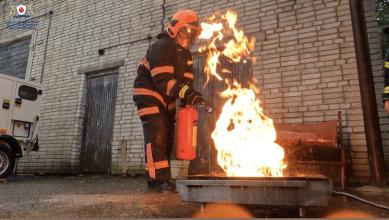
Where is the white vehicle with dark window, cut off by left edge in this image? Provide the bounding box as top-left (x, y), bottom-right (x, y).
top-left (0, 73), bottom-right (42, 178)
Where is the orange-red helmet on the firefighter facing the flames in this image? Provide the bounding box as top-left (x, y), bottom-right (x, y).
top-left (167, 10), bottom-right (201, 38)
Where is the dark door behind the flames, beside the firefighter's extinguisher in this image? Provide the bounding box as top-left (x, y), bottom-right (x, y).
top-left (189, 55), bottom-right (253, 174)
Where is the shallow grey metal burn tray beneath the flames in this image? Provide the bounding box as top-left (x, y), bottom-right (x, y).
top-left (176, 175), bottom-right (332, 207)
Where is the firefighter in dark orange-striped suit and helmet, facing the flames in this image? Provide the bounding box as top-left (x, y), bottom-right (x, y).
top-left (133, 10), bottom-right (208, 192)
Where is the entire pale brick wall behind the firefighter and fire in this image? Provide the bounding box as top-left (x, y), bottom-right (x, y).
top-left (0, 0), bottom-right (386, 183)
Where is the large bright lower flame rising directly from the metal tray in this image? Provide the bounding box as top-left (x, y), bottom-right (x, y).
top-left (212, 82), bottom-right (286, 176)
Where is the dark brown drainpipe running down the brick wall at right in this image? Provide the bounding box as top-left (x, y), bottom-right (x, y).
top-left (350, 0), bottom-right (386, 186)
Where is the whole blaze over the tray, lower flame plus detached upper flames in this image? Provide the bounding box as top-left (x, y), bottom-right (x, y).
top-left (199, 10), bottom-right (286, 176)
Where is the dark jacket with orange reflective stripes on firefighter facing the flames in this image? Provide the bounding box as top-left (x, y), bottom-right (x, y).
top-left (133, 32), bottom-right (193, 114)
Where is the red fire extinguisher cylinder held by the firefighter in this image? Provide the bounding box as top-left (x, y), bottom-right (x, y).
top-left (176, 106), bottom-right (197, 160)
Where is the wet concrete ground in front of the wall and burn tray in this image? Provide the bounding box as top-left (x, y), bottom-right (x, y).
top-left (0, 176), bottom-right (389, 218)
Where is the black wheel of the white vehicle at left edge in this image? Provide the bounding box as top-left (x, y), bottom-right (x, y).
top-left (0, 142), bottom-right (15, 178)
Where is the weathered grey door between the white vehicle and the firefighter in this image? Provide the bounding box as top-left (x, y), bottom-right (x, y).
top-left (81, 73), bottom-right (117, 174)
